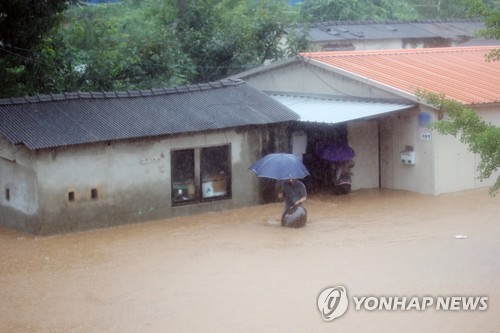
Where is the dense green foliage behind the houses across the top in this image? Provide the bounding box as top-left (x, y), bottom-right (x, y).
top-left (0, 0), bottom-right (500, 97)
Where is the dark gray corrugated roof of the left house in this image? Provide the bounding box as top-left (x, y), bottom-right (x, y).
top-left (0, 80), bottom-right (299, 149)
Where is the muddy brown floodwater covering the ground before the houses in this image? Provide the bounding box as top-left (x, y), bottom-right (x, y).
top-left (0, 189), bottom-right (500, 333)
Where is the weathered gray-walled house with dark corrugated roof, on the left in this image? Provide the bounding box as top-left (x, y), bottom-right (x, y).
top-left (0, 80), bottom-right (298, 235)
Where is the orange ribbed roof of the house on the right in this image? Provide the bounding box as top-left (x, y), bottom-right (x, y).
top-left (300, 46), bottom-right (500, 104)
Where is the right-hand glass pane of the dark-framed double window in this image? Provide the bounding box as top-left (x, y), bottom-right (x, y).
top-left (200, 145), bottom-right (231, 199)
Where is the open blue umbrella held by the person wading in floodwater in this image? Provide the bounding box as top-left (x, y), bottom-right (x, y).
top-left (248, 153), bottom-right (309, 180)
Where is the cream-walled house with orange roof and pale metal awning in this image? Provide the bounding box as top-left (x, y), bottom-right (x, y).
top-left (233, 46), bottom-right (500, 195)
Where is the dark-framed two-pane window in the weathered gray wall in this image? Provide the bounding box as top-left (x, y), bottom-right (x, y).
top-left (171, 145), bottom-right (231, 205)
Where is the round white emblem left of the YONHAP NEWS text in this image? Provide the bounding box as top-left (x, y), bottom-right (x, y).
top-left (318, 286), bottom-right (349, 321)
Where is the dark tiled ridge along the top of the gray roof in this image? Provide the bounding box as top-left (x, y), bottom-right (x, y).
top-left (0, 78), bottom-right (245, 105)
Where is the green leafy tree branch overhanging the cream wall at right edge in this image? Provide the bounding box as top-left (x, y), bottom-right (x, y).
top-left (417, 91), bottom-right (500, 195)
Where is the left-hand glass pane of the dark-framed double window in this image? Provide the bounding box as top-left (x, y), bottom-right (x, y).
top-left (170, 149), bottom-right (196, 203)
